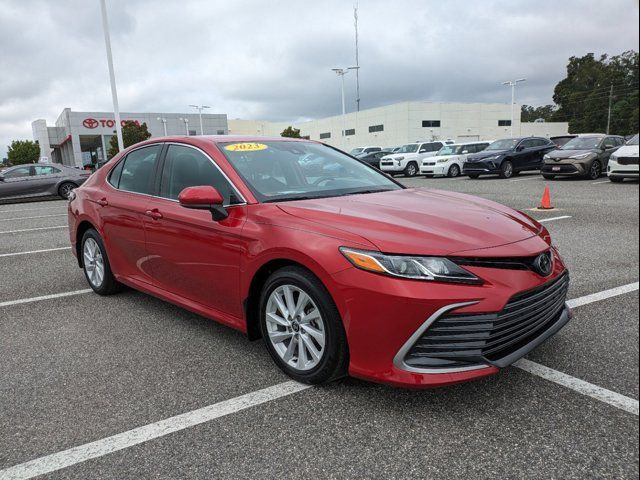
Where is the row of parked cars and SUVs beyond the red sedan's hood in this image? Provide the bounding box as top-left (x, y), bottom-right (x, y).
top-left (351, 133), bottom-right (638, 182)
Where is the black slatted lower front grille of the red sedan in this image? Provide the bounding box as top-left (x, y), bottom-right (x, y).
top-left (404, 273), bottom-right (569, 368)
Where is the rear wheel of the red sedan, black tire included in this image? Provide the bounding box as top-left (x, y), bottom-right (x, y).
top-left (80, 228), bottom-right (122, 295)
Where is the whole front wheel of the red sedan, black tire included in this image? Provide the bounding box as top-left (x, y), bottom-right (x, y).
top-left (260, 267), bottom-right (349, 384)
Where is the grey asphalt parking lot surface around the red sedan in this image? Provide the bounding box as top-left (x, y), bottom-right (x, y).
top-left (0, 175), bottom-right (639, 479)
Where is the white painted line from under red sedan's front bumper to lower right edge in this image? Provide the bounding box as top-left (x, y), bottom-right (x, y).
top-left (513, 358), bottom-right (638, 415)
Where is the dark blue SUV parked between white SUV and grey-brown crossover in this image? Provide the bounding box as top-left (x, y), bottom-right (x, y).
top-left (463, 137), bottom-right (557, 178)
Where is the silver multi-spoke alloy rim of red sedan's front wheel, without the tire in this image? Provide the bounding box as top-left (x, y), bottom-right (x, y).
top-left (265, 285), bottom-right (325, 371)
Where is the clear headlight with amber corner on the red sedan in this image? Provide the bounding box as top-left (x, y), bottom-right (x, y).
top-left (340, 247), bottom-right (482, 283)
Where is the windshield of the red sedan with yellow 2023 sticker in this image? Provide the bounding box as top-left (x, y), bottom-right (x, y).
top-left (219, 140), bottom-right (403, 202)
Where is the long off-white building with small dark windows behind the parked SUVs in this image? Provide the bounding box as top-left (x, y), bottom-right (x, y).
top-left (229, 102), bottom-right (569, 151)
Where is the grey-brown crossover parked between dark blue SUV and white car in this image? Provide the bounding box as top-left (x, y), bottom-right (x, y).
top-left (542, 134), bottom-right (624, 180)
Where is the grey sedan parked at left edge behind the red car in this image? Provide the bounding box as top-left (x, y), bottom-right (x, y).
top-left (0, 164), bottom-right (91, 202)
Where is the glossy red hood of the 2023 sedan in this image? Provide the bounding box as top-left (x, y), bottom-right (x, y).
top-left (278, 189), bottom-right (541, 255)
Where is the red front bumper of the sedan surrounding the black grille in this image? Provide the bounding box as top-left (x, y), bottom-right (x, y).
top-left (333, 246), bottom-right (571, 388)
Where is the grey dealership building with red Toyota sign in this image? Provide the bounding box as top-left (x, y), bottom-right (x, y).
top-left (31, 108), bottom-right (228, 167)
